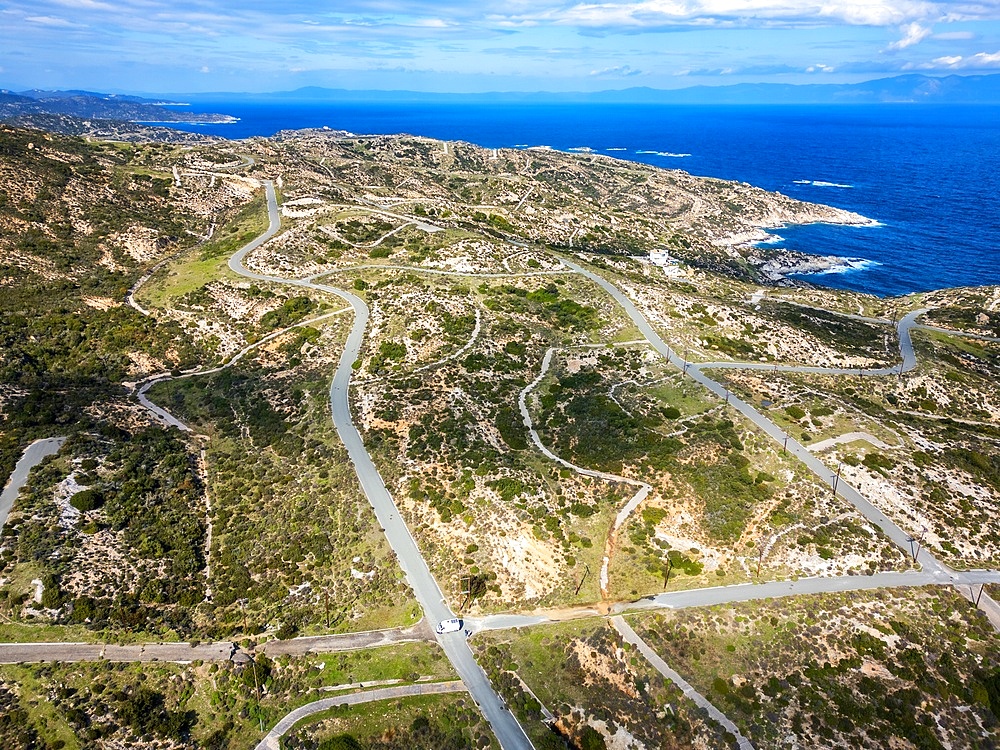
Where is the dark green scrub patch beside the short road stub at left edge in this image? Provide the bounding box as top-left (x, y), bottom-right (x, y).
top-left (0, 427), bottom-right (205, 632)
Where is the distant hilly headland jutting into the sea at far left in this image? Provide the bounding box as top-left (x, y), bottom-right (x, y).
top-left (0, 89), bottom-right (233, 122)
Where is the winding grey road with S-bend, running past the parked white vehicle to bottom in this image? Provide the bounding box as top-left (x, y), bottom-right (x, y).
top-left (229, 180), bottom-right (533, 750)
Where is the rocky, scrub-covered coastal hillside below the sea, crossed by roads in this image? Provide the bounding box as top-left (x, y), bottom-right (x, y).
top-left (0, 127), bottom-right (1000, 750)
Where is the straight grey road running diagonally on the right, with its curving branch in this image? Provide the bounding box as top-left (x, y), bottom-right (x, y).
top-left (563, 259), bottom-right (952, 582)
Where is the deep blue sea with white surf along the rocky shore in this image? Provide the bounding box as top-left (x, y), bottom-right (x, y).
top-left (168, 100), bottom-right (1000, 296)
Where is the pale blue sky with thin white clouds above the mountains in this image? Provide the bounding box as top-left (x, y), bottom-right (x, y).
top-left (0, 0), bottom-right (1000, 93)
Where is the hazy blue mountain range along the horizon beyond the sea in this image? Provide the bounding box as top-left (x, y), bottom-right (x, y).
top-left (177, 74), bottom-right (1000, 104)
